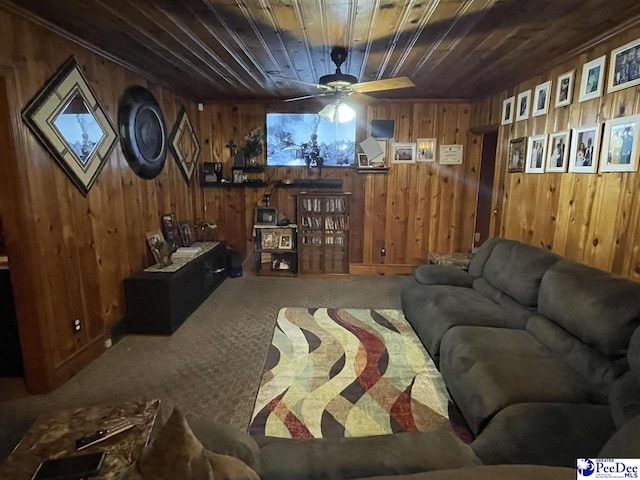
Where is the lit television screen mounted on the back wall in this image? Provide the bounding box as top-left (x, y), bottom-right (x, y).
top-left (267, 113), bottom-right (356, 167)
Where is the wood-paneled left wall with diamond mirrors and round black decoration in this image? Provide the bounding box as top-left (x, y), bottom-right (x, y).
top-left (0, 10), bottom-right (202, 391)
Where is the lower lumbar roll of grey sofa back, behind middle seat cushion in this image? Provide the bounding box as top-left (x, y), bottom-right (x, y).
top-left (526, 315), bottom-right (629, 393)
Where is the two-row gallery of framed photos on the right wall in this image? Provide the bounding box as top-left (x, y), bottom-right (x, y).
top-left (500, 38), bottom-right (640, 174)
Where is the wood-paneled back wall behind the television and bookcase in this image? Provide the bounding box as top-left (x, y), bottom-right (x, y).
top-left (200, 101), bottom-right (480, 272)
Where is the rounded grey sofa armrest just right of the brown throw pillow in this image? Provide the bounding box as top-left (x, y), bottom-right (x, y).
top-left (189, 417), bottom-right (260, 474)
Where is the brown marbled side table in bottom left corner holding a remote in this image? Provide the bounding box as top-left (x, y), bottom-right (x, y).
top-left (0, 400), bottom-right (160, 480)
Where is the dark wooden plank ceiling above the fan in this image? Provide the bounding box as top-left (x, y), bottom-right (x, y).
top-left (7, 0), bottom-right (640, 101)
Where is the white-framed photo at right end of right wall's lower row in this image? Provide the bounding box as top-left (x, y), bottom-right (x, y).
top-left (600, 115), bottom-right (640, 172)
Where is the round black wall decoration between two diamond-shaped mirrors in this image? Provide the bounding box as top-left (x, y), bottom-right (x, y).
top-left (118, 85), bottom-right (167, 180)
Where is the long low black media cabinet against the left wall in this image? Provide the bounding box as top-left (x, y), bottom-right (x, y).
top-left (124, 242), bottom-right (227, 335)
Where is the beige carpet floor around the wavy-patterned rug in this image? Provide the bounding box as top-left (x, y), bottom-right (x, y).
top-left (0, 269), bottom-right (407, 460)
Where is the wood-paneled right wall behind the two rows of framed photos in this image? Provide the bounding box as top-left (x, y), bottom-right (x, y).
top-left (472, 27), bottom-right (640, 281)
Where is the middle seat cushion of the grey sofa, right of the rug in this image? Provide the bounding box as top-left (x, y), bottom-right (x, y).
top-left (440, 327), bottom-right (606, 436)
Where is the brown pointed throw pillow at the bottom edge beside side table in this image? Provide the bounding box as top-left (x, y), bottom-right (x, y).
top-left (121, 408), bottom-right (260, 480)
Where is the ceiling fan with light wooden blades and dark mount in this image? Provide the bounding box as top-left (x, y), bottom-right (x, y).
top-left (285, 47), bottom-right (415, 102)
